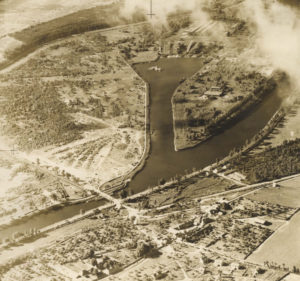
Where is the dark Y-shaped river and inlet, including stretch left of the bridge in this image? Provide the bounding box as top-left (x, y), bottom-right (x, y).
top-left (0, 58), bottom-right (281, 238)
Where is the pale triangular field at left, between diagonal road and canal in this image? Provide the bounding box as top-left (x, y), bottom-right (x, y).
top-left (0, 152), bottom-right (88, 226)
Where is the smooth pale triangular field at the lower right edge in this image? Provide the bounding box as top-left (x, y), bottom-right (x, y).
top-left (248, 212), bottom-right (300, 269)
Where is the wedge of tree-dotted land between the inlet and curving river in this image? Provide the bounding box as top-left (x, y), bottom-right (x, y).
top-left (172, 60), bottom-right (277, 151)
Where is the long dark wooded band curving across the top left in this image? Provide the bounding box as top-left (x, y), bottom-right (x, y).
top-left (0, 4), bottom-right (145, 68)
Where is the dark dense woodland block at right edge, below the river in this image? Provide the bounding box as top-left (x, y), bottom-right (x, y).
top-left (230, 139), bottom-right (300, 182)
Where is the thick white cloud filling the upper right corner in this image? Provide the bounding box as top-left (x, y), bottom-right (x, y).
top-left (244, 0), bottom-right (300, 98)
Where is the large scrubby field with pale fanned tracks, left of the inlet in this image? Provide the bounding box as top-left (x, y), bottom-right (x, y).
top-left (0, 25), bottom-right (146, 182)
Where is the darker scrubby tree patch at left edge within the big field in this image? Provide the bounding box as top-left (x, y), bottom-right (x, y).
top-left (0, 81), bottom-right (84, 150)
